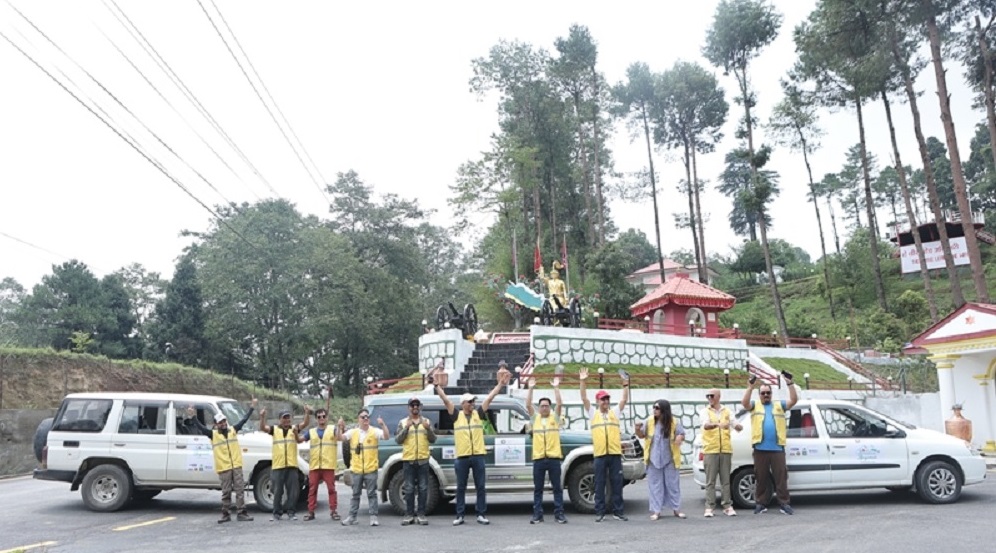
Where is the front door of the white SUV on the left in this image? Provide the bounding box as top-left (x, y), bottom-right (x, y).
top-left (166, 402), bottom-right (218, 486)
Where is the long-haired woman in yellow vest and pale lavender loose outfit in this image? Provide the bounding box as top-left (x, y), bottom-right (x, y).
top-left (636, 399), bottom-right (686, 520)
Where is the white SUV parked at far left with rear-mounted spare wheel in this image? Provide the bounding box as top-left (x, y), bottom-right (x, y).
top-left (34, 392), bottom-right (308, 511)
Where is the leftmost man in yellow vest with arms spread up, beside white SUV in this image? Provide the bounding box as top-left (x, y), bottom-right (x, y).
top-left (183, 398), bottom-right (256, 524)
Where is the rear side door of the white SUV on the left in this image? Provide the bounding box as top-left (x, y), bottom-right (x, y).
top-left (111, 400), bottom-right (169, 485)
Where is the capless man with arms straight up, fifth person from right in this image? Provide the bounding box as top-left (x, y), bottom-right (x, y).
top-left (526, 370), bottom-right (567, 524)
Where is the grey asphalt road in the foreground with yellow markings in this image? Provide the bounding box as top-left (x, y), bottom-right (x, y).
top-left (0, 471), bottom-right (996, 553)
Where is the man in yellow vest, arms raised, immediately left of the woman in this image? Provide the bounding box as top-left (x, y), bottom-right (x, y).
top-left (578, 367), bottom-right (629, 522)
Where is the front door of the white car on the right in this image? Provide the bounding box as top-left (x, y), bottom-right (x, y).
top-left (819, 405), bottom-right (909, 487)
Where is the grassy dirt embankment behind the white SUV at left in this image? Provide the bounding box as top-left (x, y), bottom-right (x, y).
top-left (0, 349), bottom-right (289, 409)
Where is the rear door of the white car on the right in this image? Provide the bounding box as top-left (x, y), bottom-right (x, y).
top-left (785, 405), bottom-right (832, 490)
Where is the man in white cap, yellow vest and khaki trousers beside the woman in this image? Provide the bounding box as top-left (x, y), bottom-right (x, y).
top-left (699, 388), bottom-right (743, 517)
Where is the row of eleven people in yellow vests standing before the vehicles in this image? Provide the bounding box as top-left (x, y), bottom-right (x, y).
top-left (186, 367), bottom-right (798, 526)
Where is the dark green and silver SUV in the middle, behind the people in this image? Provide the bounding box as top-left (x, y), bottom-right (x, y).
top-left (362, 394), bottom-right (646, 514)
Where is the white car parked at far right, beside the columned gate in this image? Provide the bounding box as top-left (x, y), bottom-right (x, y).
top-left (694, 400), bottom-right (986, 508)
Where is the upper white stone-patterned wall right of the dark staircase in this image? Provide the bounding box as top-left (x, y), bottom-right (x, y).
top-left (531, 327), bottom-right (747, 371)
